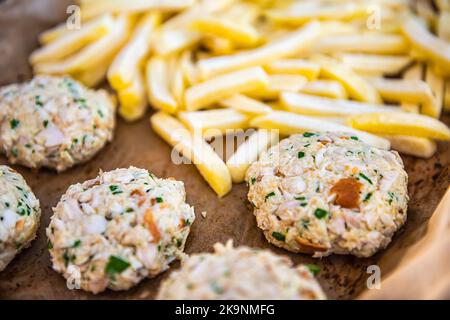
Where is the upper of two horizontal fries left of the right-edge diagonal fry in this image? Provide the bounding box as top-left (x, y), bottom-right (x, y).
top-left (311, 32), bottom-right (408, 54)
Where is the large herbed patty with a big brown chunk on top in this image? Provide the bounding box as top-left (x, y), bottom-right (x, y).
top-left (246, 132), bottom-right (408, 257)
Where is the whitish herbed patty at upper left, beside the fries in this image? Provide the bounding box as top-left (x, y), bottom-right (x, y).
top-left (0, 76), bottom-right (115, 171)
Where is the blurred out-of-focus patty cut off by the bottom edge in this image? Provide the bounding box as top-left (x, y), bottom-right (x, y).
top-left (158, 241), bottom-right (325, 300)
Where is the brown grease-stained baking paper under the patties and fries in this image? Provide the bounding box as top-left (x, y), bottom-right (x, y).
top-left (0, 0), bottom-right (450, 299)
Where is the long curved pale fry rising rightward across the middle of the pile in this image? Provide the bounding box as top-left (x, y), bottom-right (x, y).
top-left (198, 22), bottom-right (320, 79)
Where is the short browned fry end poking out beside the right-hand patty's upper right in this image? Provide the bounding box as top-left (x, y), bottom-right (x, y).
top-left (383, 135), bottom-right (437, 159)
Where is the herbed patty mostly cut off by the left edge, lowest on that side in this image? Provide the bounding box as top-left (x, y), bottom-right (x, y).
top-left (0, 166), bottom-right (41, 271)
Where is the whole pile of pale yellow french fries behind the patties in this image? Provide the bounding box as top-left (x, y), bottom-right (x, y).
top-left (30, 0), bottom-right (450, 196)
